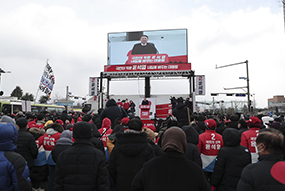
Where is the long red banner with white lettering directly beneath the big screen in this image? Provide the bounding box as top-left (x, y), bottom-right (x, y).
top-left (104, 63), bottom-right (191, 72)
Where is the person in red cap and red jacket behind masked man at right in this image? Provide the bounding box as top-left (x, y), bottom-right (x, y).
top-left (240, 116), bottom-right (262, 163)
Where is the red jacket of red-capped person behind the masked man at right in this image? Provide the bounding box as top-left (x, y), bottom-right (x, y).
top-left (240, 127), bottom-right (259, 153)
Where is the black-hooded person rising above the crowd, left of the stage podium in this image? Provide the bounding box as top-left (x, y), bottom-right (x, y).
top-left (100, 99), bottom-right (127, 128)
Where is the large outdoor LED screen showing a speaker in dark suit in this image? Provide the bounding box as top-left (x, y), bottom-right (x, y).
top-left (108, 29), bottom-right (188, 65)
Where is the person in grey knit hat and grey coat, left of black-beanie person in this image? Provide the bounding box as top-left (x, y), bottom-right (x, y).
top-left (51, 130), bottom-right (73, 163)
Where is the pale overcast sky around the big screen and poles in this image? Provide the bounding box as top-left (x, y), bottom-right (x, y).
top-left (0, 0), bottom-right (285, 107)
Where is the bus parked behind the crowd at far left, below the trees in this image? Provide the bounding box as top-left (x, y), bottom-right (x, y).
top-left (0, 100), bottom-right (65, 114)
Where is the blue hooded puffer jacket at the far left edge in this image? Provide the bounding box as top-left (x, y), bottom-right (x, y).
top-left (0, 123), bottom-right (31, 191)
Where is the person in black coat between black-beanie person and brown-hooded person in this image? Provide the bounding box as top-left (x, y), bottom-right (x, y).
top-left (108, 118), bottom-right (154, 191)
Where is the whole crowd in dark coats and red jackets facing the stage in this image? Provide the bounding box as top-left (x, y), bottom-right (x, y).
top-left (0, 98), bottom-right (285, 191)
